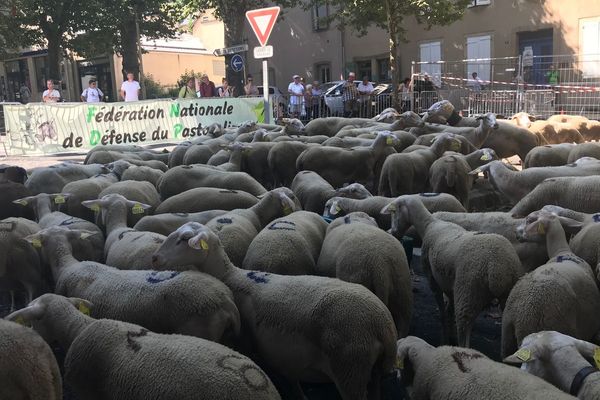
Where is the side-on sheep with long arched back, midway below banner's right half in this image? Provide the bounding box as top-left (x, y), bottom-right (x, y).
top-left (158, 165), bottom-right (267, 200)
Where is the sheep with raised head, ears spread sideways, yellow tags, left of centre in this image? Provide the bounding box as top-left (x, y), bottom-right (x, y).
top-left (82, 194), bottom-right (165, 269)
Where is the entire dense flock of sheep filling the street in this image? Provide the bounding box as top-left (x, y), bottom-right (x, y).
top-left (0, 102), bottom-right (600, 400)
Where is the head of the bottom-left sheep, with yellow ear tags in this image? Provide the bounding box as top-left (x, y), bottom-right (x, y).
top-left (4, 293), bottom-right (93, 343)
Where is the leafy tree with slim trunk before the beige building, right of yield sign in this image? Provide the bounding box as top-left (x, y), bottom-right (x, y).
top-left (305, 0), bottom-right (470, 108)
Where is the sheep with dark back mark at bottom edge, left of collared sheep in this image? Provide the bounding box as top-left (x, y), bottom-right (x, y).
top-left (398, 336), bottom-right (573, 400)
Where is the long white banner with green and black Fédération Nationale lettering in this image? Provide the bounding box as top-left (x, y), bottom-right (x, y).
top-left (4, 98), bottom-right (264, 156)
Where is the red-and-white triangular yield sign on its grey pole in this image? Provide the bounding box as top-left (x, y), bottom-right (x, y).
top-left (246, 7), bottom-right (281, 124)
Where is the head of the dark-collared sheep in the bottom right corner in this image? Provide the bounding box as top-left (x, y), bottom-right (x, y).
top-left (504, 331), bottom-right (600, 395)
